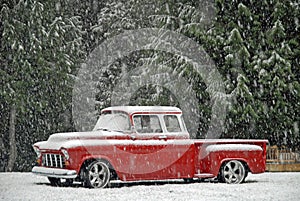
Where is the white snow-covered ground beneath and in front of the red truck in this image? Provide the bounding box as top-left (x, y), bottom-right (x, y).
top-left (0, 172), bottom-right (300, 201)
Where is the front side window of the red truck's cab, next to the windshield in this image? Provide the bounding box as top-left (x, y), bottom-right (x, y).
top-left (133, 115), bottom-right (162, 133)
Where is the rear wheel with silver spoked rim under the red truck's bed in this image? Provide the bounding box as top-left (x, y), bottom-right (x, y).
top-left (219, 160), bottom-right (247, 184)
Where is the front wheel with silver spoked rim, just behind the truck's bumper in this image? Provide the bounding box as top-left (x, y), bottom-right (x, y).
top-left (84, 160), bottom-right (110, 188)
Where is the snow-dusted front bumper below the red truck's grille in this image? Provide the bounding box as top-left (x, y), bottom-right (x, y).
top-left (31, 166), bottom-right (77, 179)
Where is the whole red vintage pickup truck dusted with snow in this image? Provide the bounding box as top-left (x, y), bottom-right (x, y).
top-left (32, 106), bottom-right (268, 188)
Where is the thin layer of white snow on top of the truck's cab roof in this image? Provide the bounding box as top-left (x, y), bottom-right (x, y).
top-left (101, 106), bottom-right (182, 114)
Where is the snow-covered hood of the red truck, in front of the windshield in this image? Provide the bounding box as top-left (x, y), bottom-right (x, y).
top-left (33, 131), bottom-right (130, 150)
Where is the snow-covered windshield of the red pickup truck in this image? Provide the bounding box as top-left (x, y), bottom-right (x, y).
top-left (93, 112), bottom-right (130, 132)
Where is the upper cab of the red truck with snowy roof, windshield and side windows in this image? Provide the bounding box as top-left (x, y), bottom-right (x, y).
top-left (93, 106), bottom-right (189, 140)
